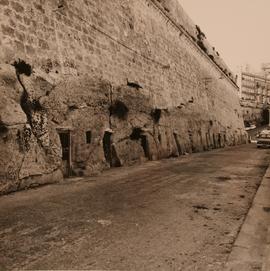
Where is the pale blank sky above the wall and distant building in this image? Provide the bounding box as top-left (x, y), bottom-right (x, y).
top-left (179, 0), bottom-right (270, 72)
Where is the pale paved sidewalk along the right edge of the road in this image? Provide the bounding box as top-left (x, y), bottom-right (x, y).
top-left (225, 166), bottom-right (270, 271)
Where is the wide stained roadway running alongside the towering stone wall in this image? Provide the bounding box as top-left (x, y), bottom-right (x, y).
top-left (0, 145), bottom-right (270, 271)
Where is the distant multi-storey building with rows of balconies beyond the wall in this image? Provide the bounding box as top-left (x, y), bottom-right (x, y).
top-left (238, 71), bottom-right (270, 126)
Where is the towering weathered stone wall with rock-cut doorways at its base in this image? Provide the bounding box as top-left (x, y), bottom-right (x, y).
top-left (0, 0), bottom-right (246, 196)
